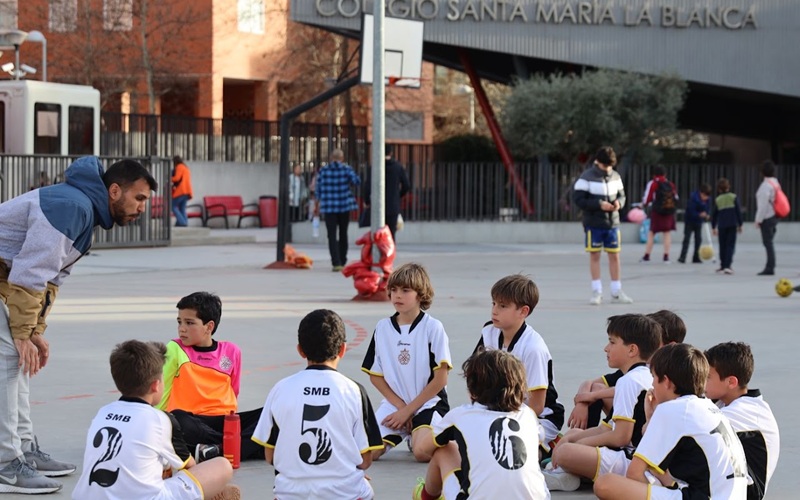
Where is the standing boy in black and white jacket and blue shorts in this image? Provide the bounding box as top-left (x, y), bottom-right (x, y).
top-left (572, 146), bottom-right (633, 305)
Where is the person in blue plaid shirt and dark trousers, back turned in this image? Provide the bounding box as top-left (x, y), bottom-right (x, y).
top-left (316, 149), bottom-right (361, 272)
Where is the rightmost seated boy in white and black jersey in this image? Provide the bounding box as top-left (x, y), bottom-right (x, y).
top-left (706, 342), bottom-right (781, 500)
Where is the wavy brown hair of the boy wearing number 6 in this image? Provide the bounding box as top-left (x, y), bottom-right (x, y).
top-left (461, 349), bottom-right (527, 412)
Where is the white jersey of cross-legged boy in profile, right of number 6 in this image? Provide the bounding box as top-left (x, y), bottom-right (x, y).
top-left (611, 363), bottom-right (653, 457)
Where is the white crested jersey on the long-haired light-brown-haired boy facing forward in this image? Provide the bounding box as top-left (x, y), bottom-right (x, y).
top-left (361, 312), bottom-right (453, 413)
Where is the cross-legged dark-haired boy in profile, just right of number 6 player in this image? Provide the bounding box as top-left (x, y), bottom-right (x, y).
top-left (544, 314), bottom-right (661, 491)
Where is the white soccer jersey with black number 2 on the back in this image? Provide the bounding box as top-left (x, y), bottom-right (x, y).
top-left (72, 397), bottom-right (185, 500)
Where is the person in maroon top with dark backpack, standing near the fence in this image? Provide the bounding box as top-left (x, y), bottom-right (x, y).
top-left (641, 165), bottom-right (678, 264)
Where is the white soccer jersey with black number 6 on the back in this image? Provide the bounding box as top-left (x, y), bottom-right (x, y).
top-left (433, 403), bottom-right (550, 500)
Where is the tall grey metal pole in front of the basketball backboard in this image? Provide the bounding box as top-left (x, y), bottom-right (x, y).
top-left (370, 0), bottom-right (386, 264)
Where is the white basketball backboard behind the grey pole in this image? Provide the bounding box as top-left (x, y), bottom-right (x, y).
top-left (361, 14), bottom-right (424, 88)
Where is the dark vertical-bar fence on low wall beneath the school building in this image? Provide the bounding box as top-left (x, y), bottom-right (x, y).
top-left (390, 161), bottom-right (800, 221)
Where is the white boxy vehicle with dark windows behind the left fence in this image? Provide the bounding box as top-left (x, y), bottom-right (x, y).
top-left (0, 80), bottom-right (100, 155)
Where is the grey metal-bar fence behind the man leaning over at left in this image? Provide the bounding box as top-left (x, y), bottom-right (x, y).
top-left (0, 155), bottom-right (172, 248)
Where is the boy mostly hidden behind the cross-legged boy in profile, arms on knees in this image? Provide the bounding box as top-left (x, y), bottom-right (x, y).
top-left (567, 309), bottom-right (686, 429)
